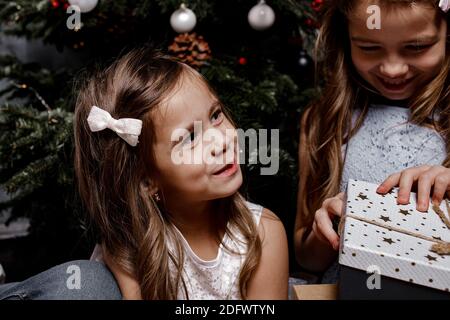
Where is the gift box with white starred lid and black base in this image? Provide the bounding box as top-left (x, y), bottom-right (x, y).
top-left (339, 180), bottom-right (450, 299)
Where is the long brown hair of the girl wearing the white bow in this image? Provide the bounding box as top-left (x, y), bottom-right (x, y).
top-left (74, 48), bottom-right (261, 299)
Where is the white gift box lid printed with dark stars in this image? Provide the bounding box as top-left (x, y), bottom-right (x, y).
top-left (339, 180), bottom-right (450, 291)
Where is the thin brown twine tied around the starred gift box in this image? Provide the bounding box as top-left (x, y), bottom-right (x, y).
top-left (338, 200), bottom-right (450, 255)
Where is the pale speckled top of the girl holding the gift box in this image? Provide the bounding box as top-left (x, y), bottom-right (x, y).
top-left (323, 105), bottom-right (447, 283)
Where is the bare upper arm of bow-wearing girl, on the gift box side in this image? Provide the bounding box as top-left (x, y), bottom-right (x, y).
top-left (246, 209), bottom-right (289, 300)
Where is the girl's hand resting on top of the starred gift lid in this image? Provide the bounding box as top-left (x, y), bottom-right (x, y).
top-left (377, 165), bottom-right (450, 212)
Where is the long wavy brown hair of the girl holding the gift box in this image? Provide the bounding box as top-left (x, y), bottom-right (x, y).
top-left (297, 0), bottom-right (450, 228)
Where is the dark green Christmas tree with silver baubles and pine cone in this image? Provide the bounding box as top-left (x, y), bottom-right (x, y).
top-left (0, 0), bottom-right (321, 278)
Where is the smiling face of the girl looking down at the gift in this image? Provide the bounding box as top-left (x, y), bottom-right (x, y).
top-left (349, 1), bottom-right (447, 100)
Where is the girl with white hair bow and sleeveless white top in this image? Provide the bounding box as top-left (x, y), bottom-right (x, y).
top-left (74, 49), bottom-right (288, 299)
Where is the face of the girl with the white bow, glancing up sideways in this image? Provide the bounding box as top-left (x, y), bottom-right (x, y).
top-left (150, 72), bottom-right (242, 203)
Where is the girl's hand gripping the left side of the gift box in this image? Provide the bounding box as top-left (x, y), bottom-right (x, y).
top-left (313, 192), bottom-right (344, 250)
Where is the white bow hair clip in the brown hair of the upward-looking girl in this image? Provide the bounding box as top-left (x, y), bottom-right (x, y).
top-left (87, 106), bottom-right (142, 147)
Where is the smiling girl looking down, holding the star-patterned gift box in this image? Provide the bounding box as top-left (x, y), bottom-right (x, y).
top-left (294, 0), bottom-right (450, 282)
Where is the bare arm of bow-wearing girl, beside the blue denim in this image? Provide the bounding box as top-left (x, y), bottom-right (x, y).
top-left (102, 246), bottom-right (142, 300)
